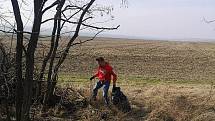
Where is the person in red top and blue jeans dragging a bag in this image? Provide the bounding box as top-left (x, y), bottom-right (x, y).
top-left (90, 57), bottom-right (117, 105)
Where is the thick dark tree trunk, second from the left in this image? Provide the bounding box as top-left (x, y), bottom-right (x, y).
top-left (21, 0), bottom-right (43, 121)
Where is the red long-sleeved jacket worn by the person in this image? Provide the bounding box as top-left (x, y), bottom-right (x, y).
top-left (94, 63), bottom-right (117, 84)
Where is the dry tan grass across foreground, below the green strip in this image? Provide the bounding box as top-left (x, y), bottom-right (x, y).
top-left (40, 84), bottom-right (215, 121)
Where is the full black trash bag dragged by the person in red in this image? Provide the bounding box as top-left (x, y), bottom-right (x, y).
top-left (111, 87), bottom-right (131, 112)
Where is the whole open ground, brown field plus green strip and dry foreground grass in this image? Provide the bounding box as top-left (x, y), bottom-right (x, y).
top-left (1, 38), bottom-right (215, 121)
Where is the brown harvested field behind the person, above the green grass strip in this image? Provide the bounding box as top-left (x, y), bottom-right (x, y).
top-left (58, 38), bottom-right (215, 83)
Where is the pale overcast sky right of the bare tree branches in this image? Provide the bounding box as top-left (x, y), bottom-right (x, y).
top-left (97, 0), bottom-right (215, 39)
